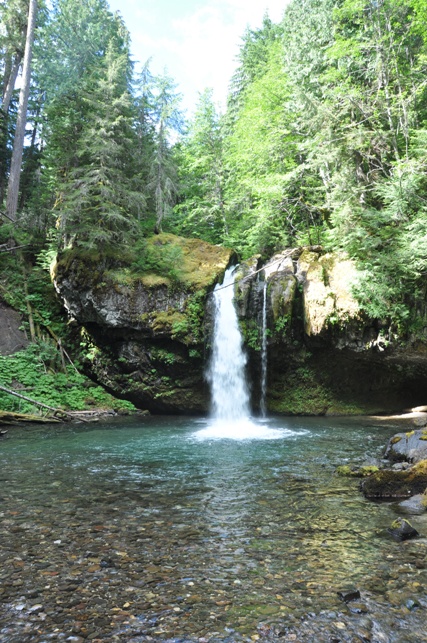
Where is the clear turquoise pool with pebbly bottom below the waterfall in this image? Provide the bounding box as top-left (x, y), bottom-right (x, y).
top-left (0, 417), bottom-right (427, 643)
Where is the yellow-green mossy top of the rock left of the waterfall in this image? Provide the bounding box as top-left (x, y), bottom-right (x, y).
top-left (56, 233), bottom-right (231, 290)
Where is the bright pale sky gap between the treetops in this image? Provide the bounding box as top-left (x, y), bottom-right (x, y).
top-left (109, 0), bottom-right (287, 113)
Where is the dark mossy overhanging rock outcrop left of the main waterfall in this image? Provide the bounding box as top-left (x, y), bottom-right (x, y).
top-left (53, 234), bottom-right (231, 413)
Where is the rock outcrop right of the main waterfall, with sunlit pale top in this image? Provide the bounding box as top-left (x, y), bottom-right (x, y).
top-left (236, 246), bottom-right (427, 414)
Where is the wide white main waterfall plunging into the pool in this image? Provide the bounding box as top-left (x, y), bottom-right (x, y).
top-left (208, 268), bottom-right (250, 421)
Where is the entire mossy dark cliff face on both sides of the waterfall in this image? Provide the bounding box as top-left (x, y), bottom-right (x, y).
top-left (53, 235), bottom-right (427, 414)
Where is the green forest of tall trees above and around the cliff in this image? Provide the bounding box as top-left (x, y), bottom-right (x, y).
top-left (0, 0), bottom-right (427, 416)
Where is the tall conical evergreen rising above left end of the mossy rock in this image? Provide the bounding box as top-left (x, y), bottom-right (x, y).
top-left (54, 19), bottom-right (144, 249)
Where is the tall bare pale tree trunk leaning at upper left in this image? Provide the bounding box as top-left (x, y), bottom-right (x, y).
top-left (6, 0), bottom-right (37, 221)
